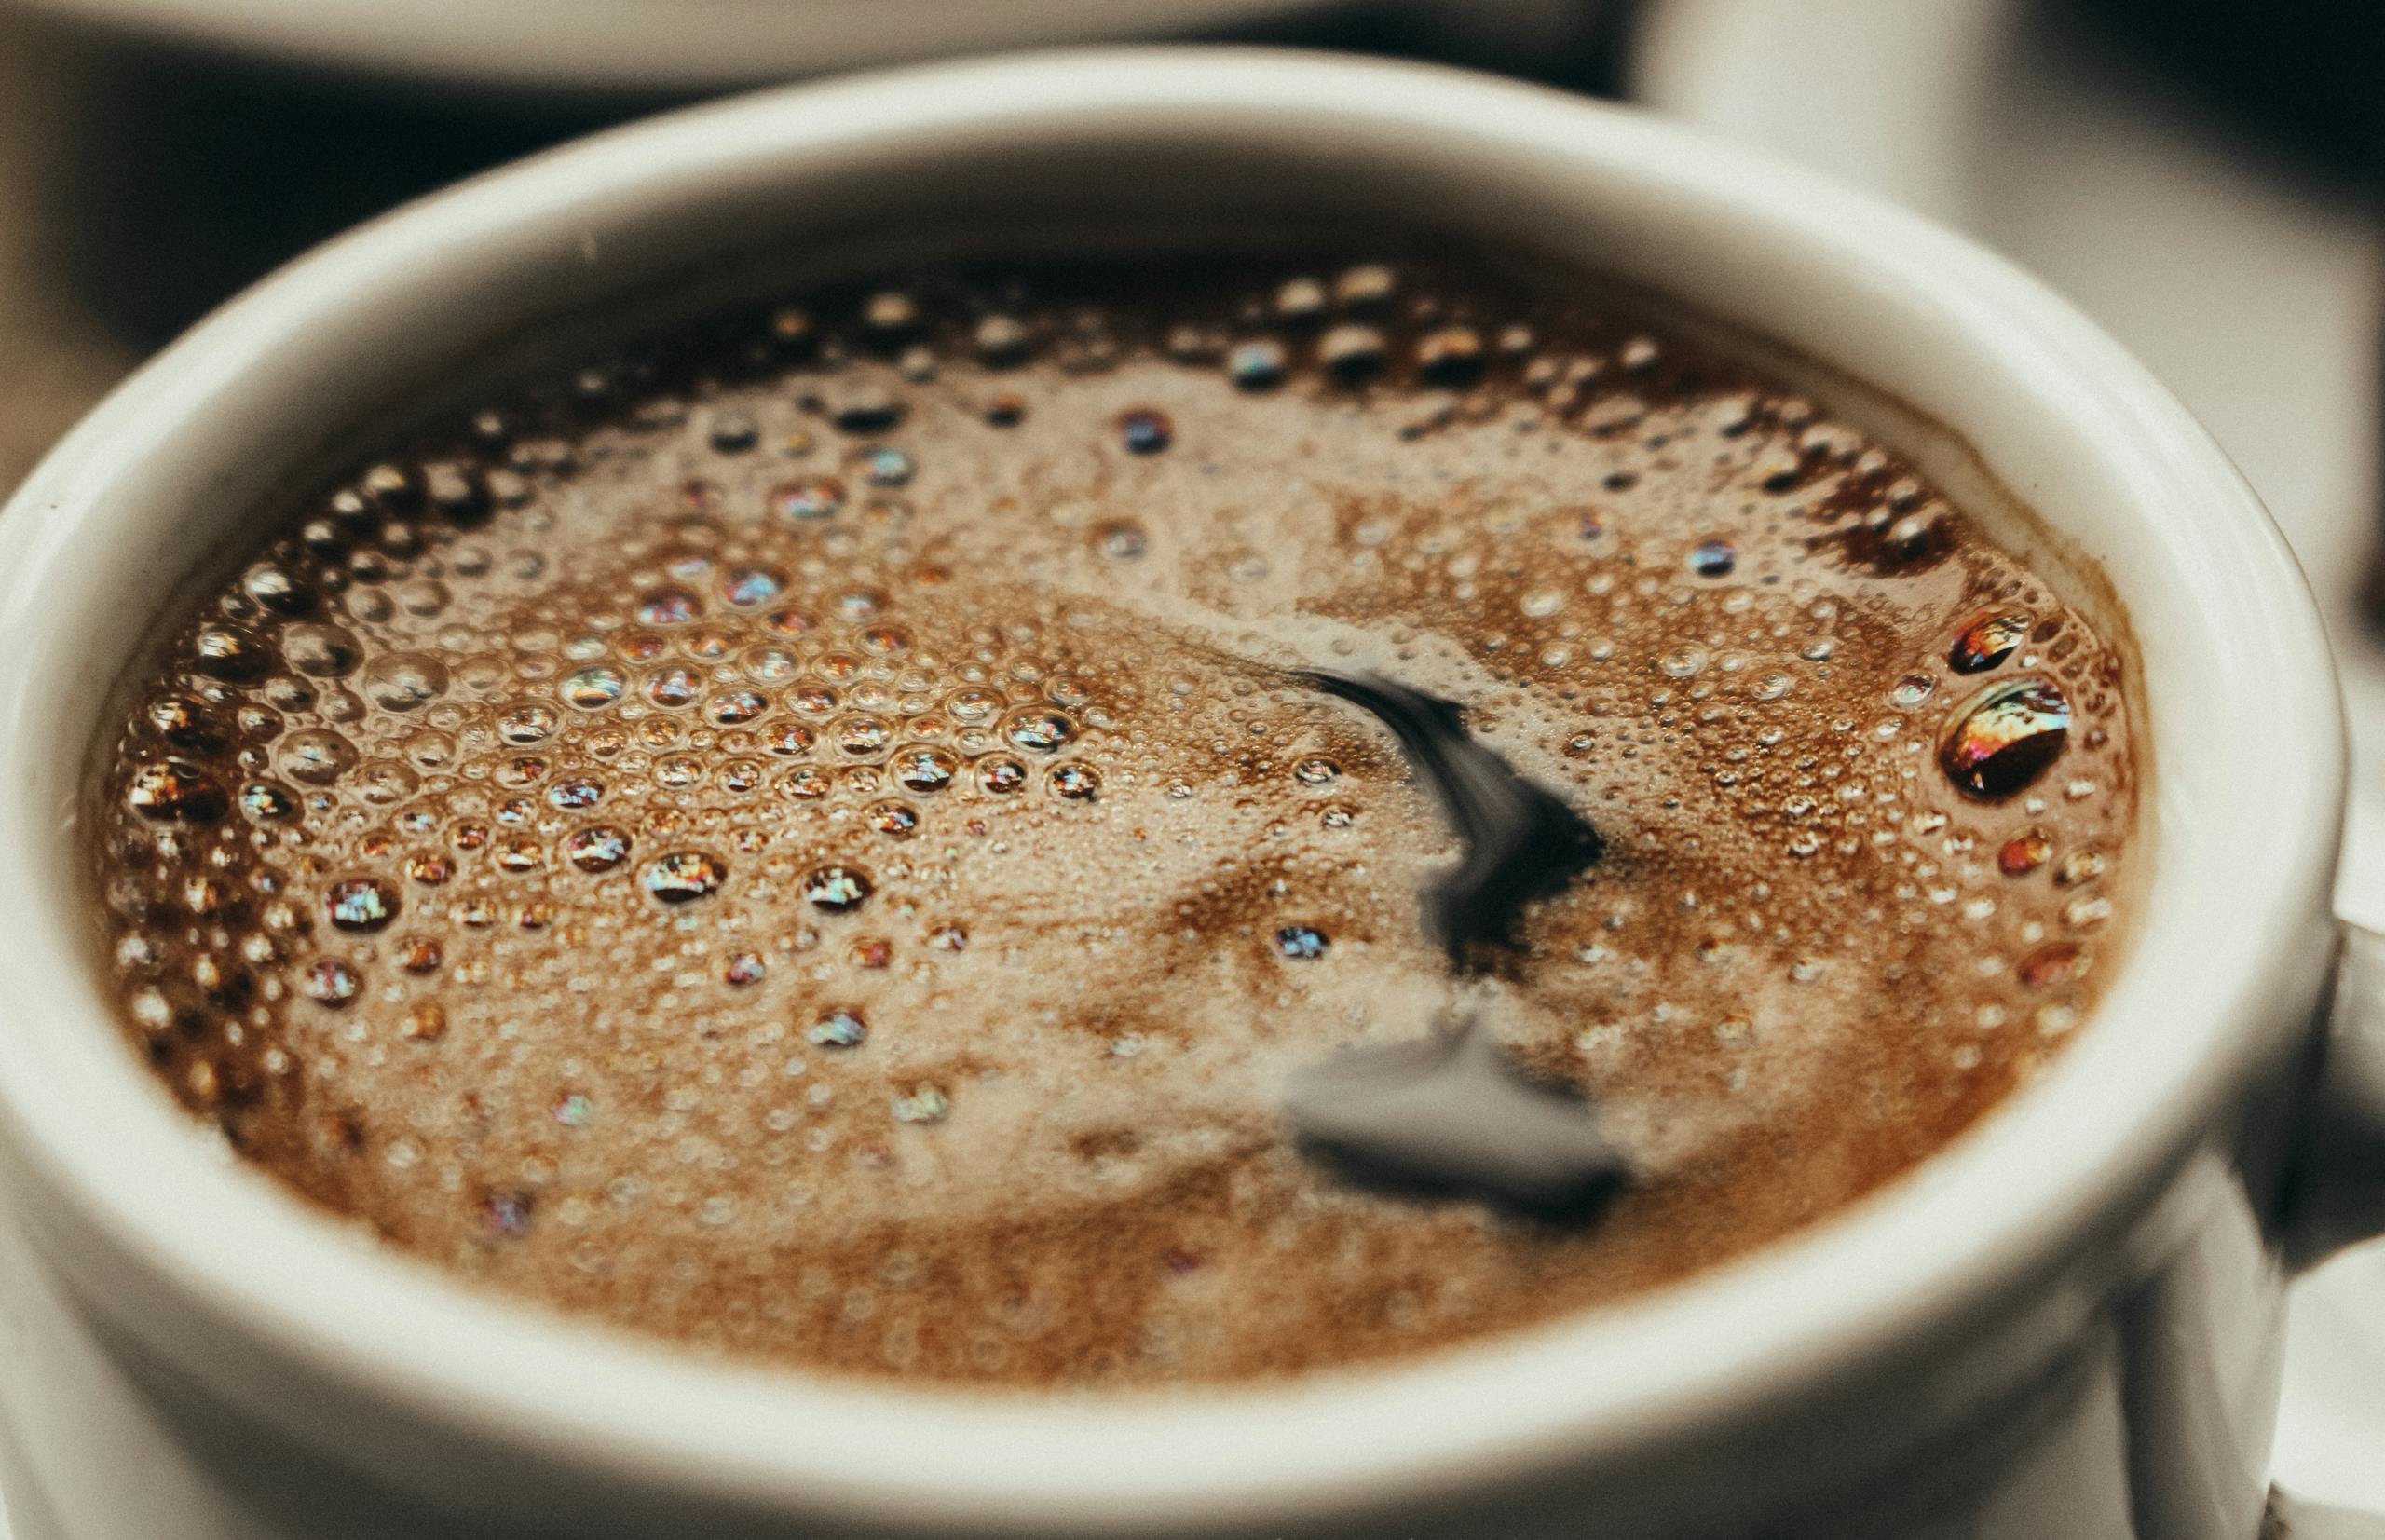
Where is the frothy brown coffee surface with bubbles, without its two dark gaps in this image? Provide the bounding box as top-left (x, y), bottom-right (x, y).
top-left (93, 257), bottom-right (2139, 1385)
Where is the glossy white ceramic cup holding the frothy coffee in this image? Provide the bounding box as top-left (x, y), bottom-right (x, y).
top-left (0, 50), bottom-right (2385, 1540)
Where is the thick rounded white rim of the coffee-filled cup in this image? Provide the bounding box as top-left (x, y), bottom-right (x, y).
top-left (0, 48), bottom-right (2342, 1533)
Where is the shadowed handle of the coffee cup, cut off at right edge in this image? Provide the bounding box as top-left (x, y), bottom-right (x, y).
top-left (2284, 920), bottom-right (2385, 1271)
